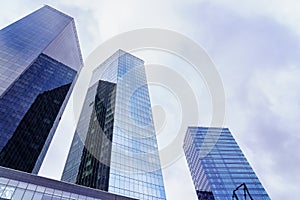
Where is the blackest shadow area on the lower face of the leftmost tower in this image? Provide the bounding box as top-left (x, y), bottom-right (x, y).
top-left (0, 83), bottom-right (71, 172)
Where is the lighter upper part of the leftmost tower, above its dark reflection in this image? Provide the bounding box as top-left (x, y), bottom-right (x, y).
top-left (0, 6), bottom-right (82, 96)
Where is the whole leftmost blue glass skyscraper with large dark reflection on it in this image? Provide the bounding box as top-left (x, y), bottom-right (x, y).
top-left (0, 6), bottom-right (82, 173)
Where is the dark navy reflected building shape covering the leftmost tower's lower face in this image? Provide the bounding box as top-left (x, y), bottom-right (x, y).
top-left (0, 54), bottom-right (76, 172)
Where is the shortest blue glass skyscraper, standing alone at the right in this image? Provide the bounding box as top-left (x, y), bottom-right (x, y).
top-left (184, 127), bottom-right (270, 200)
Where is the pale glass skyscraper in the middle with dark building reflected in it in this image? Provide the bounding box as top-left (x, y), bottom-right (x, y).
top-left (62, 50), bottom-right (166, 200)
